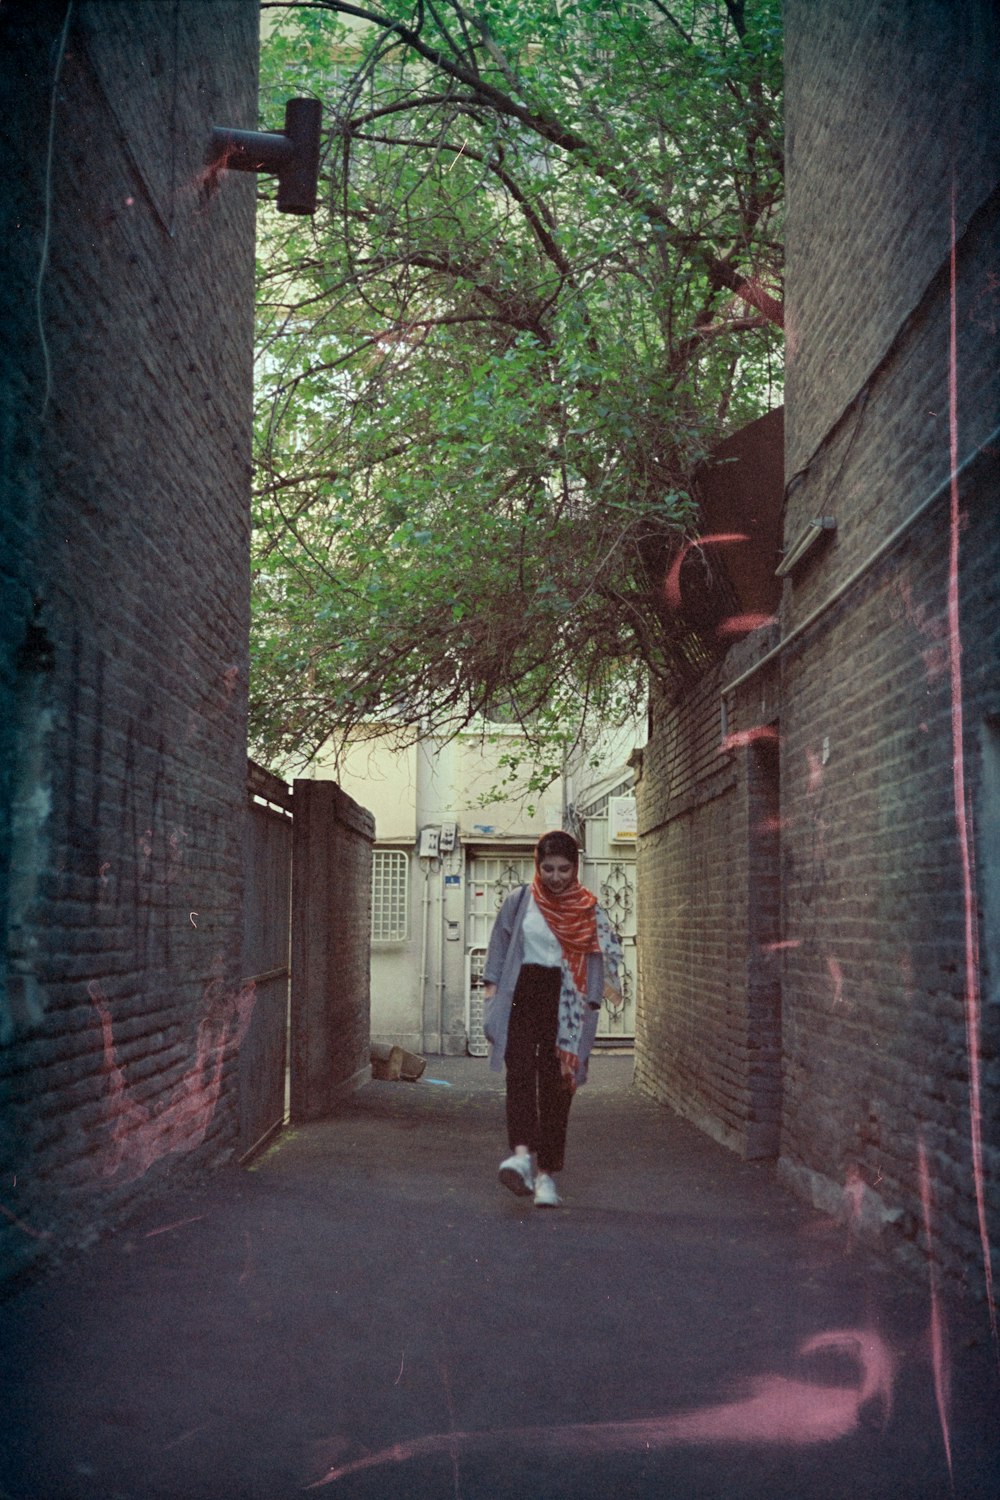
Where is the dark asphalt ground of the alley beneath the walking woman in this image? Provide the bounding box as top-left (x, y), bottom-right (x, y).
top-left (0, 1056), bottom-right (1000, 1500)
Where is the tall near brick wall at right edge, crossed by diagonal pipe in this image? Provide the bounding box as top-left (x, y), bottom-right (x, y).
top-left (781, 0), bottom-right (1000, 1286)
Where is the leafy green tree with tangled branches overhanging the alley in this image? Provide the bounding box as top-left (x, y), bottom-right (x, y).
top-left (252, 0), bottom-right (783, 761)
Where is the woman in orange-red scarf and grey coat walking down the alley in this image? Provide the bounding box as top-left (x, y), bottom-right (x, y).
top-left (483, 833), bottom-right (622, 1208)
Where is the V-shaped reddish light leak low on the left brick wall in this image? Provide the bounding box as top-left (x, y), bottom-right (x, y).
top-left (87, 980), bottom-right (255, 1182)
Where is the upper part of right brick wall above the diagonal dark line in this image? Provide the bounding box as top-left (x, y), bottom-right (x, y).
top-left (784, 0), bottom-right (1000, 477)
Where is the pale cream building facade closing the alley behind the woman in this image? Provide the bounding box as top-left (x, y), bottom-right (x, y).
top-left (305, 725), bottom-right (636, 1056)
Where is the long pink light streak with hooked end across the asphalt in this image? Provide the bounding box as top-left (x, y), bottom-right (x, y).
top-left (306, 1329), bottom-right (895, 1490)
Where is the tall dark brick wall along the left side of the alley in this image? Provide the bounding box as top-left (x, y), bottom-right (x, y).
top-left (0, 0), bottom-right (258, 1290)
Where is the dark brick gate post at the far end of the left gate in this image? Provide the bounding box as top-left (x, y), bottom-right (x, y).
top-left (289, 779), bottom-right (375, 1122)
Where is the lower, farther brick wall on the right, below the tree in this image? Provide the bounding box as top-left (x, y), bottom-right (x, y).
top-left (636, 633), bottom-right (780, 1157)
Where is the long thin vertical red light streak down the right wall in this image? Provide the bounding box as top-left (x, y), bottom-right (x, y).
top-left (948, 179), bottom-right (1000, 1349)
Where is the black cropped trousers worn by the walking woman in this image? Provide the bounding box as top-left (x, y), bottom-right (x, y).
top-left (504, 963), bottom-right (573, 1172)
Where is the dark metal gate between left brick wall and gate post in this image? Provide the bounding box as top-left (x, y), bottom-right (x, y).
top-left (240, 761), bottom-right (292, 1160)
